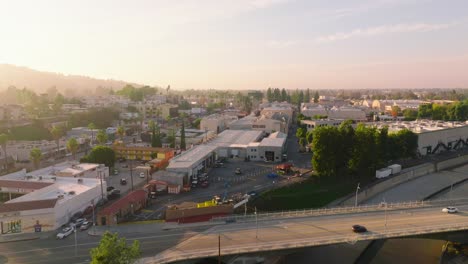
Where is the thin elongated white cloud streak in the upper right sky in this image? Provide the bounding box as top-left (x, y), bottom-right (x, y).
top-left (316, 23), bottom-right (457, 43)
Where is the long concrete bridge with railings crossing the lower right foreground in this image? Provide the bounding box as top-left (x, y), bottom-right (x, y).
top-left (139, 199), bottom-right (468, 263)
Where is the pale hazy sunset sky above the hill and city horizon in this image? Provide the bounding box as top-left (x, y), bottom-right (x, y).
top-left (0, 0), bottom-right (468, 89)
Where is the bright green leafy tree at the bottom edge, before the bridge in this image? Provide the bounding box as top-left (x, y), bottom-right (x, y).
top-left (90, 231), bottom-right (141, 264)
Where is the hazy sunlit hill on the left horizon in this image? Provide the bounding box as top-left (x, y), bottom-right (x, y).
top-left (0, 64), bottom-right (142, 96)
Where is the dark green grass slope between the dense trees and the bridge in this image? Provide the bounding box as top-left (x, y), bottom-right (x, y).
top-left (254, 177), bottom-right (362, 211)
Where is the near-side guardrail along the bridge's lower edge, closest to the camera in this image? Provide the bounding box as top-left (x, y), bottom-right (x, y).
top-left (146, 223), bottom-right (468, 263)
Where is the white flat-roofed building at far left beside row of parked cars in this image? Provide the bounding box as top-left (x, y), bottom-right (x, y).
top-left (0, 165), bottom-right (106, 236)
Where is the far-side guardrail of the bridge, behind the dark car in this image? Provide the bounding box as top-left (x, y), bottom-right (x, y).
top-left (211, 198), bottom-right (468, 222)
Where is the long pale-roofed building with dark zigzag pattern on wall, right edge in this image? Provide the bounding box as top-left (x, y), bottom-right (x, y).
top-left (372, 120), bottom-right (468, 156)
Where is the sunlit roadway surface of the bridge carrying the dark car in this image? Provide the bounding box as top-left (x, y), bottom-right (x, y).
top-left (147, 204), bottom-right (468, 263)
